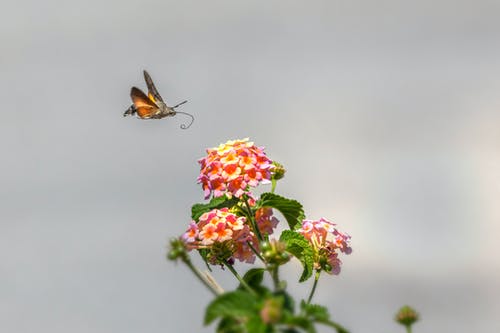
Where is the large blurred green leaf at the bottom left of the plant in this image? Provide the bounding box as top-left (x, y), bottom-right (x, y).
top-left (204, 290), bottom-right (257, 325)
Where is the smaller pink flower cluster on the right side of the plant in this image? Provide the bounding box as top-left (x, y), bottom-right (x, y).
top-left (298, 218), bottom-right (352, 274)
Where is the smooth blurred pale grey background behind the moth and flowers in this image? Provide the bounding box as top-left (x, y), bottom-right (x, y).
top-left (0, 0), bottom-right (500, 333)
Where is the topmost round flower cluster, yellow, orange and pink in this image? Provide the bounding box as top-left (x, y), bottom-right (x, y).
top-left (198, 139), bottom-right (273, 199)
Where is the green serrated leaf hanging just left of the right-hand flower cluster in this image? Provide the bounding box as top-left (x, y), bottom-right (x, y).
top-left (280, 230), bottom-right (314, 282)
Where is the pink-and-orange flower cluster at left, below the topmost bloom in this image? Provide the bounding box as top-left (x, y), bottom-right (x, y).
top-left (181, 208), bottom-right (255, 263)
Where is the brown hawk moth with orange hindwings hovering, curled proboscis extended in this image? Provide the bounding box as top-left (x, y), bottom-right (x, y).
top-left (123, 71), bottom-right (194, 129)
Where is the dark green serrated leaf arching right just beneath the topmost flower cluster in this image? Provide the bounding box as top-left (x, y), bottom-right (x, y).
top-left (257, 192), bottom-right (305, 230)
